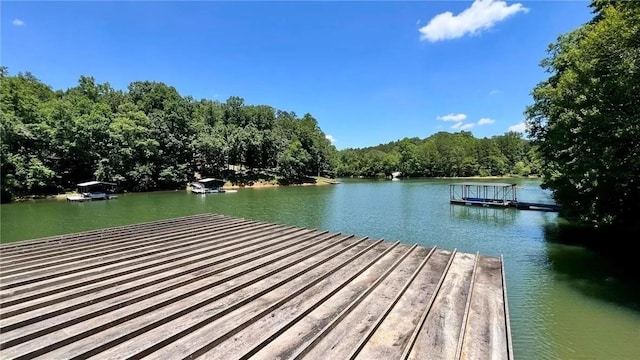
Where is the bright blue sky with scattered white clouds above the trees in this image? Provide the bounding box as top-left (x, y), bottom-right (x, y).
top-left (0, 0), bottom-right (592, 149)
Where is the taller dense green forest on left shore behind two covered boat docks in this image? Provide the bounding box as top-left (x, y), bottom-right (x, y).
top-left (0, 68), bottom-right (337, 202)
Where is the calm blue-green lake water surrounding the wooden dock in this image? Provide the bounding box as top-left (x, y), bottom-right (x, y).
top-left (0, 180), bottom-right (640, 359)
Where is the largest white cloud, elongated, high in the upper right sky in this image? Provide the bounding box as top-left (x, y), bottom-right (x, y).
top-left (419, 0), bottom-right (529, 42)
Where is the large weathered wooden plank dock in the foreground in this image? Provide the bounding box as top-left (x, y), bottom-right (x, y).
top-left (0, 214), bottom-right (513, 360)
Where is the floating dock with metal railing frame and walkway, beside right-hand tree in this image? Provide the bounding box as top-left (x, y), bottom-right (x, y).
top-left (449, 182), bottom-right (560, 212)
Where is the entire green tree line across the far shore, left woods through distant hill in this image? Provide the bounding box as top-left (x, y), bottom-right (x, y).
top-left (0, 68), bottom-right (540, 202)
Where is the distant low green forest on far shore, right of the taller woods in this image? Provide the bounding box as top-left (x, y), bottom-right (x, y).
top-left (336, 131), bottom-right (540, 177)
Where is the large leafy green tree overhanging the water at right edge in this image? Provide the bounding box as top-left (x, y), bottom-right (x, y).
top-left (526, 0), bottom-right (640, 226)
